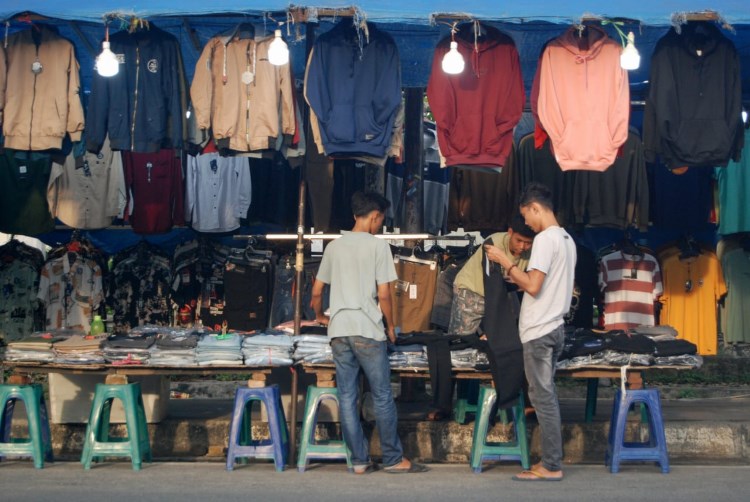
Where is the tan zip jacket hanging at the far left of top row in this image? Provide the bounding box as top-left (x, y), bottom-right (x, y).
top-left (0, 25), bottom-right (84, 150)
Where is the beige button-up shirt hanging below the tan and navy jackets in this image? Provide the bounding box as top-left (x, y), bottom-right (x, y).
top-left (47, 140), bottom-right (125, 229)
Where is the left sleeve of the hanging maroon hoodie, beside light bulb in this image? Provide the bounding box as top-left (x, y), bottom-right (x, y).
top-left (427, 37), bottom-right (458, 157)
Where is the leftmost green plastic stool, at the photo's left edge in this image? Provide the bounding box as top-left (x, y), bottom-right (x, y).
top-left (0, 384), bottom-right (53, 469)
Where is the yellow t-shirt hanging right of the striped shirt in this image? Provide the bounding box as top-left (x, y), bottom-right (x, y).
top-left (659, 249), bottom-right (727, 355)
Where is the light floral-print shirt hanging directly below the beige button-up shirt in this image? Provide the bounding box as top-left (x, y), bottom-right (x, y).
top-left (37, 253), bottom-right (104, 333)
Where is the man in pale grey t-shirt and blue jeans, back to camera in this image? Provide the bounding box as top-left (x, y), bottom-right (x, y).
top-left (312, 192), bottom-right (427, 474)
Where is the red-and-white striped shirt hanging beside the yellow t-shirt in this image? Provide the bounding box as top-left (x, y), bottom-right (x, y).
top-left (599, 251), bottom-right (664, 330)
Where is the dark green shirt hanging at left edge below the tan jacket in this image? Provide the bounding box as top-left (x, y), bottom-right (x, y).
top-left (0, 148), bottom-right (55, 235)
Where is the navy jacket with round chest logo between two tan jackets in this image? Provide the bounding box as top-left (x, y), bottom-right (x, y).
top-left (86, 24), bottom-right (187, 153)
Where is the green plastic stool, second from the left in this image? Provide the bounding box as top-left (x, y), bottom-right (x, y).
top-left (81, 383), bottom-right (152, 471)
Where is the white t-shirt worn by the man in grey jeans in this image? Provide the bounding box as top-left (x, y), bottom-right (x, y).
top-left (518, 226), bottom-right (576, 343)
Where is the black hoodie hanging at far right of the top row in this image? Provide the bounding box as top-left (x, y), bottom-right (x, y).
top-left (643, 23), bottom-right (744, 169)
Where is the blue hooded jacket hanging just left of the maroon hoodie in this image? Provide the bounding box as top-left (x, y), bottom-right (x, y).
top-left (305, 19), bottom-right (401, 157)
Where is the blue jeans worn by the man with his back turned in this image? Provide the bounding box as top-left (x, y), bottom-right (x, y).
top-left (331, 336), bottom-right (403, 467)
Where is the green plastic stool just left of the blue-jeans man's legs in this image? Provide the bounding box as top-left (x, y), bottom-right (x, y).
top-left (297, 386), bottom-right (352, 472)
